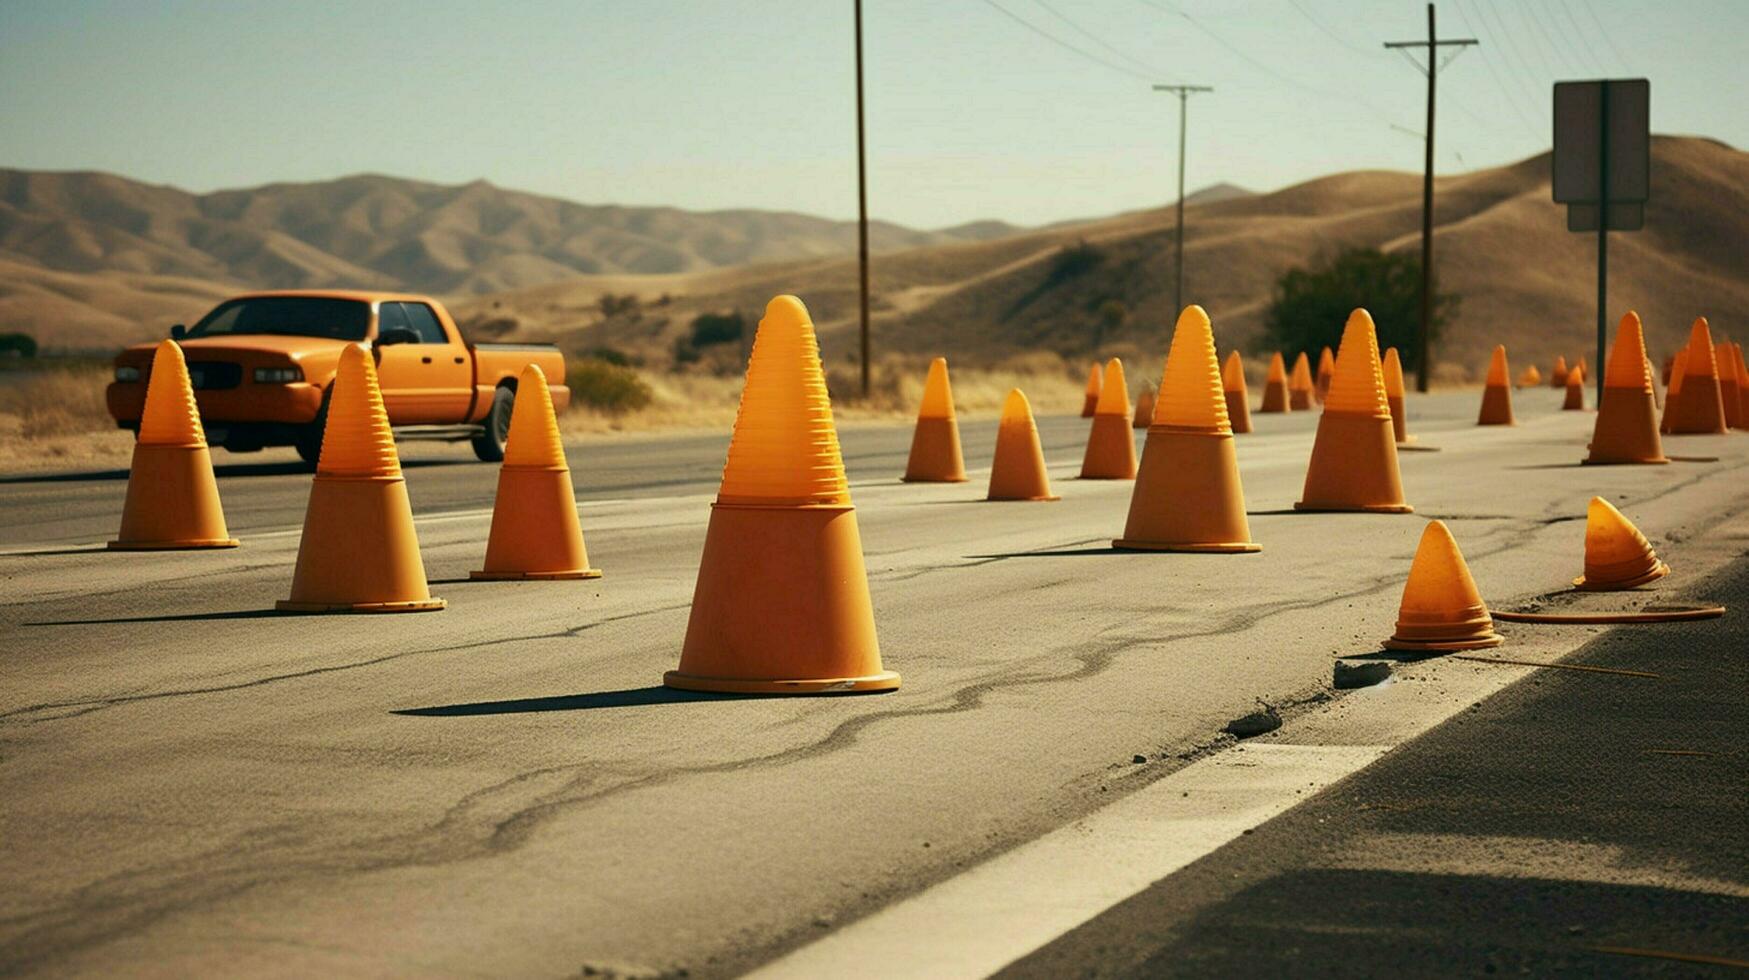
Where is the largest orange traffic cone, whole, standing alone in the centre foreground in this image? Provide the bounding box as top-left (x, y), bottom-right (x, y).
top-left (663, 296), bottom-right (899, 695)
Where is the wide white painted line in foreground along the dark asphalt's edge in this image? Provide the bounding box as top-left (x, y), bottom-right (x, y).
top-left (749, 742), bottom-right (1387, 980)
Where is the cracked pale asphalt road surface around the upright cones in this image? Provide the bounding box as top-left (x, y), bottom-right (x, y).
top-left (0, 389), bottom-right (1749, 977)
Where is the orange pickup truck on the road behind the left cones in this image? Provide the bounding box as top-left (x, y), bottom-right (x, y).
top-left (108, 291), bottom-right (570, 464)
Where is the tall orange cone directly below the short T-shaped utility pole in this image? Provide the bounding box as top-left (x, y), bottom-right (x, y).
top-left (1111, 306), bottom-right (1263, 553)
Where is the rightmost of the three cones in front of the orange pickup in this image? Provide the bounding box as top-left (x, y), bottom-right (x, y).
top-left (469, 364), bottom-right (602, 579)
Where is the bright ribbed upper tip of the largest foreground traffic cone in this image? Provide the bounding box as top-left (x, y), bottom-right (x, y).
top-left (717, 296), bottom-right (850, 506)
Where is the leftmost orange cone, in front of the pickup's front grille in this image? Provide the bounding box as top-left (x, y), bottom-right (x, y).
top-left (108, 340), bottom-right (236, 551)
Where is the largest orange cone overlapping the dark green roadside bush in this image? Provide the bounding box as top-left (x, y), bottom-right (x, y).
top-left (1294, 310), bottom-right (1415, 515)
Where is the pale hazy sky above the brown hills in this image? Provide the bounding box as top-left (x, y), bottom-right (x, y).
top-left (0, 0), bottom-right (1749, 228)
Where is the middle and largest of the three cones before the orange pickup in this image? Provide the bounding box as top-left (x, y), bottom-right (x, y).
top-left (278, 343), bottom-right (444, 613)
